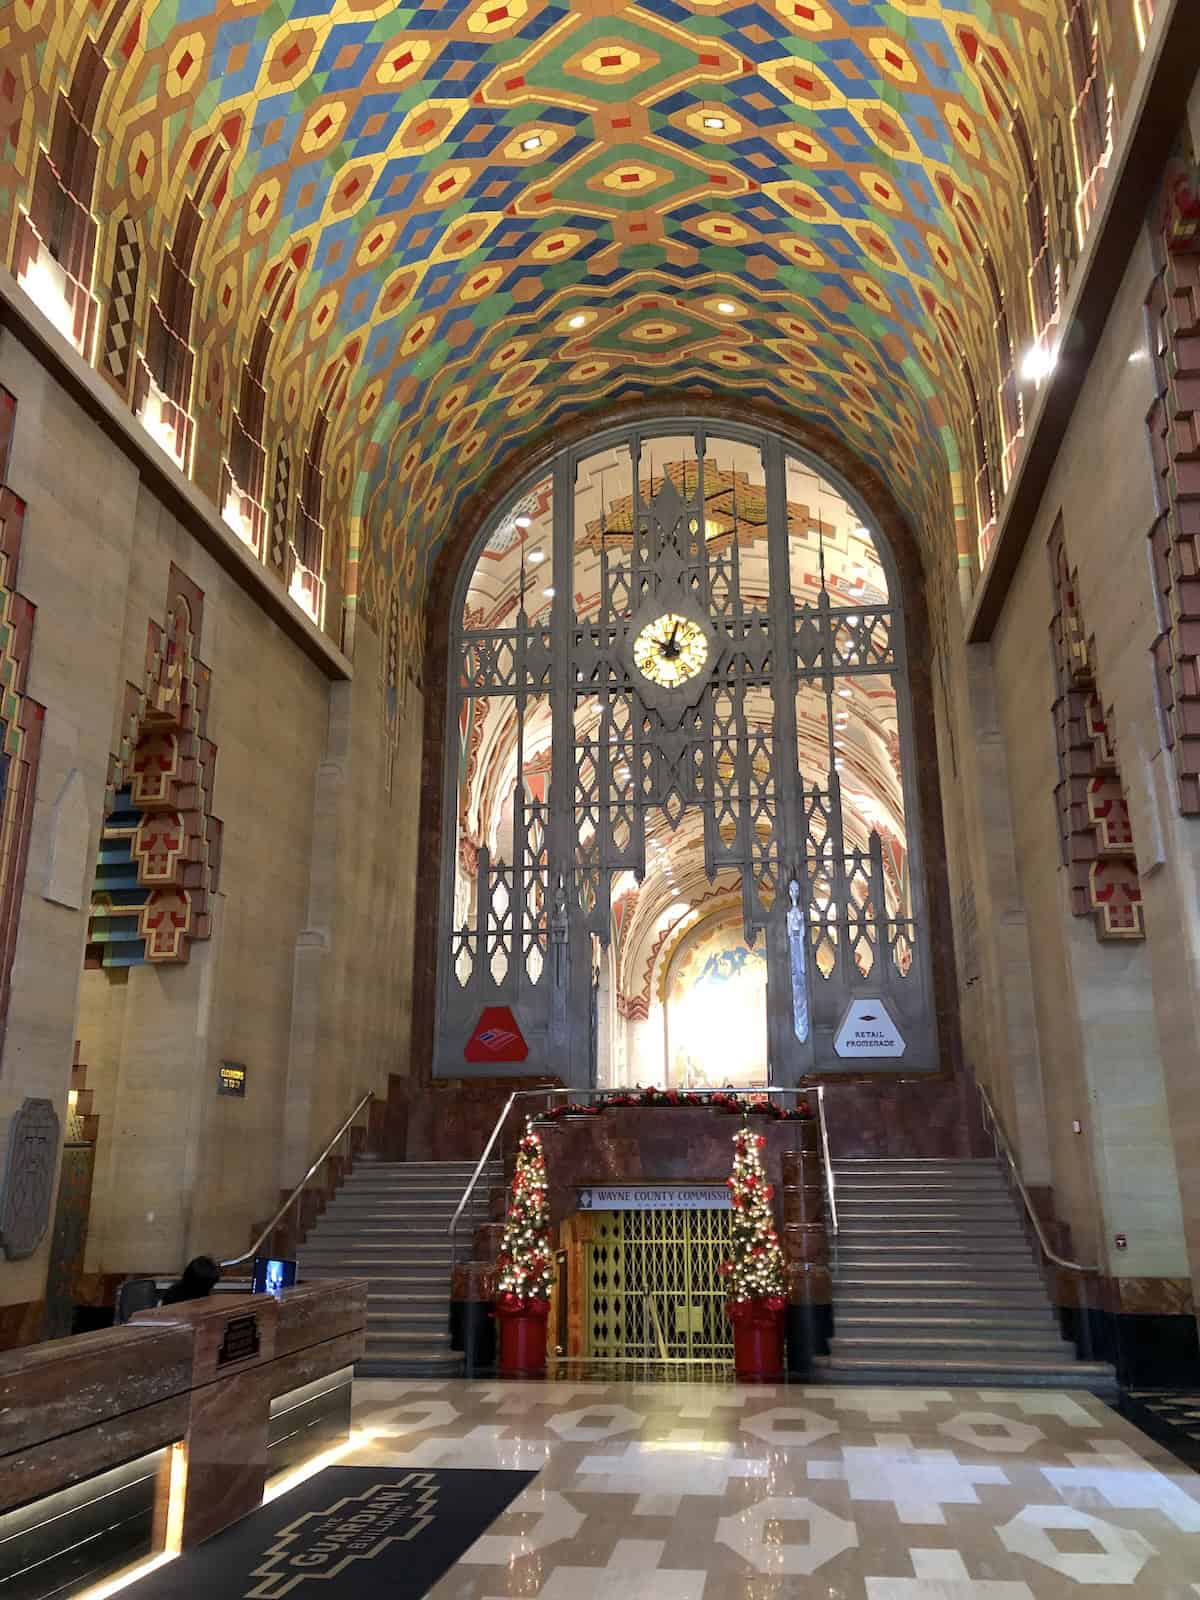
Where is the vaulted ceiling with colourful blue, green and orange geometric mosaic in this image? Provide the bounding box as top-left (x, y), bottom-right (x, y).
top-left (0, 0), bottom-right (1152, 656)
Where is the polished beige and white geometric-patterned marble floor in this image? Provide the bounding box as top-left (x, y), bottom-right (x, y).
top-left (346, 1379), bottom-right (1200, 1600)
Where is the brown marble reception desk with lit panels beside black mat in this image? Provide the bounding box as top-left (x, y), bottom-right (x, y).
top-left (0, 1280), bottom-right (366, 1600)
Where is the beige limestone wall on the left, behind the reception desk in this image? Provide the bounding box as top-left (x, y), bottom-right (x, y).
top-left (0, 333), bottom-right (419, 1320)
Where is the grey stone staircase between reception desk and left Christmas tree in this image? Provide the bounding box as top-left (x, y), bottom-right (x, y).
top-left (299, 1162), bottom-right (504, 1378)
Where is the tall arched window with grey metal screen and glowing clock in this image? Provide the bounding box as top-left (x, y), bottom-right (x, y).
top-left (434, 418), bottom-right (939, 1086)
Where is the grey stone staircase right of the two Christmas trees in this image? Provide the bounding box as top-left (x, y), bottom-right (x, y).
top-left (818, 1160), bottom-right (1115, 1394)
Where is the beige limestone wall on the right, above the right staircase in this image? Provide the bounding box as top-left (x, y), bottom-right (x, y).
top-left (952, 222), bottom-right (1200, 1310)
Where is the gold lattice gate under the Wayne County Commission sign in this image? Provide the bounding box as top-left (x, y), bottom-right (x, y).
top-left (586, 1211), bottom-right (733, 1362)
